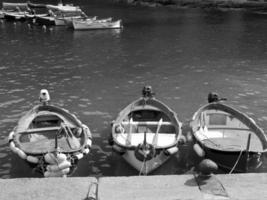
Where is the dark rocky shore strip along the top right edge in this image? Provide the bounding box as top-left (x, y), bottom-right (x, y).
top-left (115, 0), bottom-right (267, 12)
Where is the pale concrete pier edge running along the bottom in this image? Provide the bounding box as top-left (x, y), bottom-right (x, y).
top-left (0, 173), bottom-right (267, 200)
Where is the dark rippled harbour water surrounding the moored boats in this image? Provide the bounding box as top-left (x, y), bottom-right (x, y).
top-left (0, 0), bottom-right (267, 178)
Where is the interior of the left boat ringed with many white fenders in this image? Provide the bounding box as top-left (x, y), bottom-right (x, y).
top-left (17, 111), bottom-right (85, 153)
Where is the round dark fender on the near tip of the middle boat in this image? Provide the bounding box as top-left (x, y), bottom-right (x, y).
top-left (135, 144), bottom-right (156, 160)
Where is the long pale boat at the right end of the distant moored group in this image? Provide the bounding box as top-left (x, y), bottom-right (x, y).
top-left (72, 18), bottom-right (122, 30)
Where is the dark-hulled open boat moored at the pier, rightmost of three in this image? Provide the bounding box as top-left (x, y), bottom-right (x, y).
top-left (190, 93), bottom-right (267, 173)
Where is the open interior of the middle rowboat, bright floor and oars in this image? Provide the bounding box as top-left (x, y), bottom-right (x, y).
top-left (117, 110), bottom-right (178, 148)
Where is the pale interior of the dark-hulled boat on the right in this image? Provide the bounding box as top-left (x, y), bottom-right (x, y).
top-left (195, 109), bottom-right (263, 151)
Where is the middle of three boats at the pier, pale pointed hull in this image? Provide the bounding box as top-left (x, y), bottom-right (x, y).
top-left (110, 86), bottom-right (181, 175)
